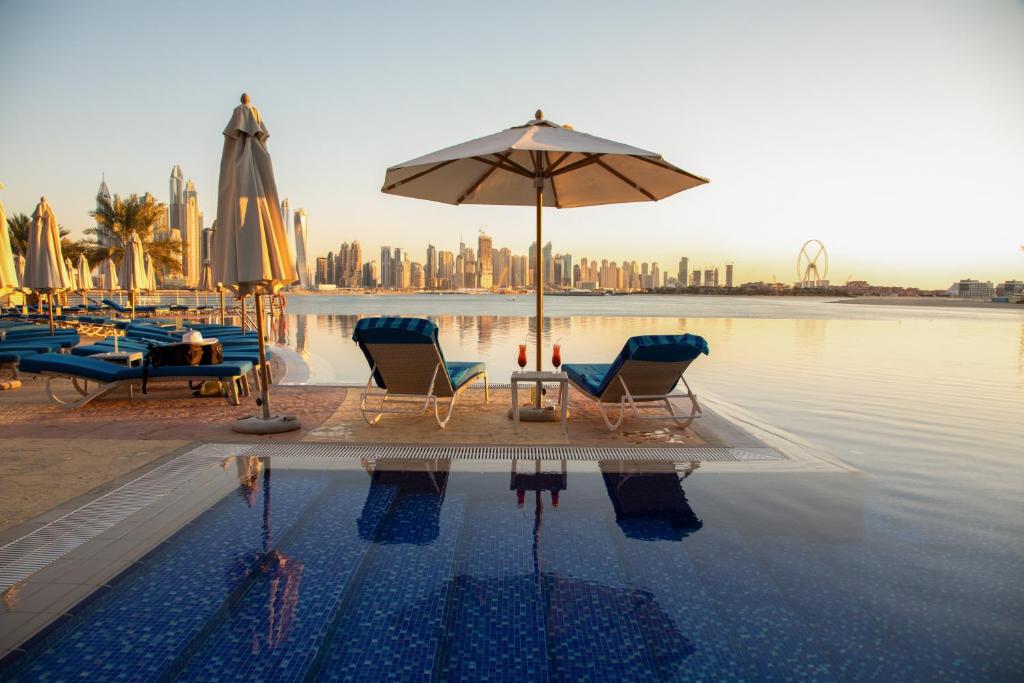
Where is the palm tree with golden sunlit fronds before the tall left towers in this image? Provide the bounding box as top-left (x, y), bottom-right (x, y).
top-left (85, 194), bottom-right (181, 273)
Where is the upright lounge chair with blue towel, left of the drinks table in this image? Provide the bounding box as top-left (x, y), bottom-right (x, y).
top-left (352, 317), bottom-right (490, 429)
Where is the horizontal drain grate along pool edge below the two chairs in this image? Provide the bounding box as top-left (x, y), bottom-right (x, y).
top-left (241, 443), bottom-right (784, 462)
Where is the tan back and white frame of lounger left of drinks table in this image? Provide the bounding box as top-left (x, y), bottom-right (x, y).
top-left (359, 344), bottom-right (490, 429)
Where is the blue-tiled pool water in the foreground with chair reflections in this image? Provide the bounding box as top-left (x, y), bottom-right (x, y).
top-left (0, 456), bottom-right (1024, 681)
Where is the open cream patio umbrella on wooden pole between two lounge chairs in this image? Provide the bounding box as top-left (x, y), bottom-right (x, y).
top-left (381, 110), bottom-right (708, 420)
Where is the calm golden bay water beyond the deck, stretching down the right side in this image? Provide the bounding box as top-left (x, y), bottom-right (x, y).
top-left (274, 296), bottom-right (1024, 674)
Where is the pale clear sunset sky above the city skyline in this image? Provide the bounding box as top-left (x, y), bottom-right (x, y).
top-left (0, 0), bottom-right (1024, 289)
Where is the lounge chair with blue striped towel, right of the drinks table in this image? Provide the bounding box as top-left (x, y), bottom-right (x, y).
top-left (562, 335), bottom-right (708, 431)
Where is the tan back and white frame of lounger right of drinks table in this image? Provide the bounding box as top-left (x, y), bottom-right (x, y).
top-left (569, 360), bottom-right (703, 431)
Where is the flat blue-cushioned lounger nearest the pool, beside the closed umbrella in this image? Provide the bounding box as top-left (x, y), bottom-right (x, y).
top-left (18, 353), bottom-right (253, 409)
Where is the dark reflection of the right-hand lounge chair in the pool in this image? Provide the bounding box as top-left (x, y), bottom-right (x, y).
top-left (599, 460), bottom-right (703, 541)
